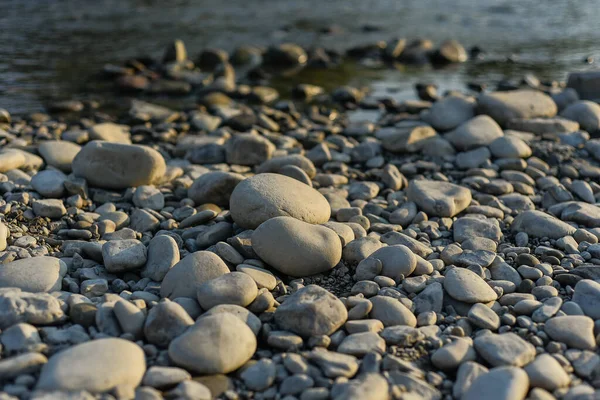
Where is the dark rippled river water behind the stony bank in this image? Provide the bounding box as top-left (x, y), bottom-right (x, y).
top-left (0, 0), bottom-right (600, 113)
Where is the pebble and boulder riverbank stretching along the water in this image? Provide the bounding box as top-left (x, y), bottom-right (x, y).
top-left (0, 40), bottom-right (600, 400)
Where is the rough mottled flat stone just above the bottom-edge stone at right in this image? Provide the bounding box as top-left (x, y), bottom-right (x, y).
top-left (473, 332), bottom-right (535, 367)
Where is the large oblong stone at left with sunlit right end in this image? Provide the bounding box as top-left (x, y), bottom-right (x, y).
top-left (73, 141), bottom-right (166, 189)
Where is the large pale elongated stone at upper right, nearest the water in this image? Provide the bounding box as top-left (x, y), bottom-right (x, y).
top-left (477, 90), bottom-right (558, 127)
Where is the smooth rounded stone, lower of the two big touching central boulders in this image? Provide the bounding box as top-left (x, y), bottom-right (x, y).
top-left (252, 217), bottom-right (342, 276)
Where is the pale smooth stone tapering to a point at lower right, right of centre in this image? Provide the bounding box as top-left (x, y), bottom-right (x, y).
top-left (444, 267), bottom-right (498, 304)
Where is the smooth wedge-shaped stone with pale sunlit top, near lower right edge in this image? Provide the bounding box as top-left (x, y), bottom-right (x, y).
top-left (544, 315), bottom-right (596, 350)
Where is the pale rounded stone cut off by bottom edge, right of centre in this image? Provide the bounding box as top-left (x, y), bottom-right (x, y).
top-left (461, 367), bottom-right (529, 400)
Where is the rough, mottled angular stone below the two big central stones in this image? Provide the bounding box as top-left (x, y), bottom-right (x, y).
top-left (275, 285), bottom-right (348, 337)
